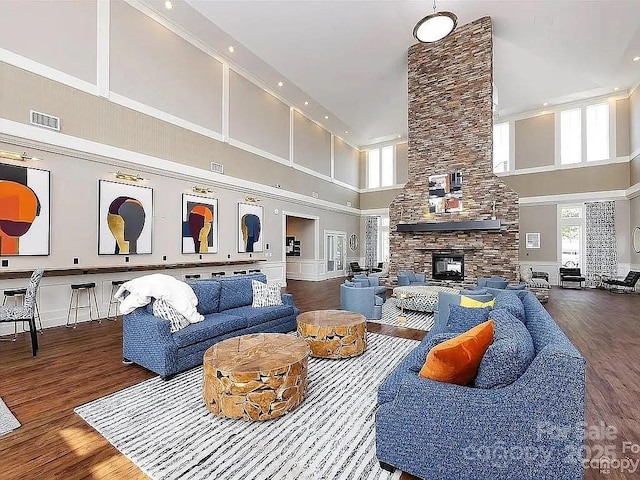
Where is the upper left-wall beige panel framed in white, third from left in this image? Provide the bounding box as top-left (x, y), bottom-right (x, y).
top-left (229, 70), bottom-right (291, 160)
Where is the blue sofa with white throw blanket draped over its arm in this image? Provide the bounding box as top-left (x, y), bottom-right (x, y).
top-left (122, 274), bottom-right (300, 378)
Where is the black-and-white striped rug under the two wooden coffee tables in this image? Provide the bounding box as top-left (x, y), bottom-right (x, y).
top-left (75, 333), bottom-right (417, 480)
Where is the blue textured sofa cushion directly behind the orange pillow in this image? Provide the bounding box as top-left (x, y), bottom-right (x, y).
top-left (474, 308), bottom-right (535, 388)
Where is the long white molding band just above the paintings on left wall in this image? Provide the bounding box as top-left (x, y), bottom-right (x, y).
top-left (0, 118), bottom-right (360, 216)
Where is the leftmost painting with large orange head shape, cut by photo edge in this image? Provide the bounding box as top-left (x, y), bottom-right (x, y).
top-left (0, 163), bottom-right (51, 256)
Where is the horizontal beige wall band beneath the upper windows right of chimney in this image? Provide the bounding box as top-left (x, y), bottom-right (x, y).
top-left (502, 162), bottom-right (629, 197)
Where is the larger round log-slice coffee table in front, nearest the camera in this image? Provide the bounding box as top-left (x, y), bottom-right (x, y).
top-left (203, 333), bottom-right (309, 420)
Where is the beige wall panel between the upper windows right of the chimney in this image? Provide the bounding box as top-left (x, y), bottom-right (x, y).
top-left (515, 113), bottom-right (555, 170)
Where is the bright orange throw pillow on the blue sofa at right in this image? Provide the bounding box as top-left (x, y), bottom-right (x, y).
top-left (419, 320), bottom-right (494, 385)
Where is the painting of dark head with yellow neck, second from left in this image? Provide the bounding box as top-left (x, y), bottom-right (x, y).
top-left (98, 180), bottom-right (153, 255)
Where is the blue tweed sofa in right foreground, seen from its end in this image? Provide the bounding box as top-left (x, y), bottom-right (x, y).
top-left (376, 291), bottom-right (585, 480)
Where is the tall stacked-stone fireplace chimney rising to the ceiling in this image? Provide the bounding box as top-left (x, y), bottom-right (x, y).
top-left (389, 17), bottom-right (518, 280)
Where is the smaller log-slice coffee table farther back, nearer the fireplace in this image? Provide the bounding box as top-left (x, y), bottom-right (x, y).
top-left (298, 310), bottom-right (367, 358)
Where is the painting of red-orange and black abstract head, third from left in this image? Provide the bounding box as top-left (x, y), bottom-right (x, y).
top-left (182, 193), bottom-right (218, 253)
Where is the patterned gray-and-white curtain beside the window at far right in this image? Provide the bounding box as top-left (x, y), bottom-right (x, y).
top-left (583, 202), bottom-right (618, 286)
